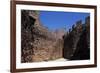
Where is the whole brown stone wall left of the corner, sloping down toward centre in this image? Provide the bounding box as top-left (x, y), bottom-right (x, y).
top-left (21, 10), bottom-right (63, 63)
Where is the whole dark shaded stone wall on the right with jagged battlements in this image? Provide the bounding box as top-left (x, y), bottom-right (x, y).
top-left (63, 16), bottom-right (90, 60)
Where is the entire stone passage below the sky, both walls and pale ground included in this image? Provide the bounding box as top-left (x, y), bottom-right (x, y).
top-left (21, 10), bottom-right (90, 63)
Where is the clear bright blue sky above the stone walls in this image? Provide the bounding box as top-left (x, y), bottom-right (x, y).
top-left (39, 11), bottom-right (90, 30)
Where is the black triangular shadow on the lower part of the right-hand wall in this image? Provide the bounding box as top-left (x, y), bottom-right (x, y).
top-left (70, 28), bottom-right (90, 60)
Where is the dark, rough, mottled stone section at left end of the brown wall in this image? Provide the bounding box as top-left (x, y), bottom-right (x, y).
top-left (21, 10), bottom-right (35, 63)
